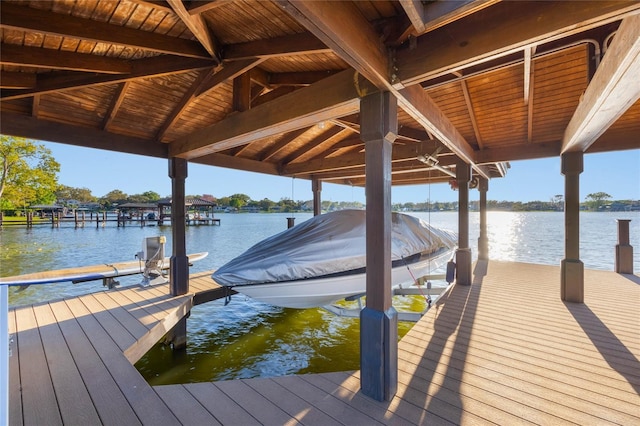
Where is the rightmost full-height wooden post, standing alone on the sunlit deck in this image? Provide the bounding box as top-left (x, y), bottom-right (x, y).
top-left (560, 151), bottom-right (584, 303)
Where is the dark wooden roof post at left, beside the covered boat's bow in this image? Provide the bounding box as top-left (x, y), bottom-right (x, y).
top-left (169, 157), bottom-right (189, 296)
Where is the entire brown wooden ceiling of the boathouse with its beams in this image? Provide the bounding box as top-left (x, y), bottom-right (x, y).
top-left (0, 0), bottom-right (640, 185)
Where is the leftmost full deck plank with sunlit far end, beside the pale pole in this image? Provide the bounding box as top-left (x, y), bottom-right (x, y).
top-left (16, 306), bottom-right (62, 425)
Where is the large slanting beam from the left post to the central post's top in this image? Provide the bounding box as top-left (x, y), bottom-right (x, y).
top-left (169, 70), bottom-right (375, 160)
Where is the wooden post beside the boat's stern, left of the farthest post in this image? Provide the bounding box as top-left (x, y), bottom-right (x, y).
top-left (456, 159), bottom-right (471, 285)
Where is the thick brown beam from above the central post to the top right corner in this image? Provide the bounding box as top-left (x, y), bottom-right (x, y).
top-left (396, 0), bottom-right (640, 85)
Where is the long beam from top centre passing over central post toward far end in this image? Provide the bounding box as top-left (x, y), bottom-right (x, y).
top-left (283, 1), bottom-right (484, 176)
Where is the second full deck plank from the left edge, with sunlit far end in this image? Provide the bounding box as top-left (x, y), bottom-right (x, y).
top-left (34, 304), bottom-right (100, 424)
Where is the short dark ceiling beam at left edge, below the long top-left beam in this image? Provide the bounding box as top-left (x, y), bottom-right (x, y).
top-left (0, 43), bottom-right (131, 74)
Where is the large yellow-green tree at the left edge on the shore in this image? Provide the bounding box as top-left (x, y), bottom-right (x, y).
top-left (0, 135), bottom-right (60, 208)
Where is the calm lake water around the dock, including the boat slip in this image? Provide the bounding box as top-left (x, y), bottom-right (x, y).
top-left (0, 212), bottom-right (640, 384)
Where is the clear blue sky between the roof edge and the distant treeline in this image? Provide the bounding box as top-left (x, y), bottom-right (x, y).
top-left (40, 142), bottom-right (640, 203)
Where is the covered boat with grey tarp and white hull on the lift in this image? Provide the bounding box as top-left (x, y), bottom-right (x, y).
top-left (212, 210), bottom-right (457, 308)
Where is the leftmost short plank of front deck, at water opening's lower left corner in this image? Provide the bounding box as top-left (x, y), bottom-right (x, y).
top-left (153, 385), bottom-right (221, 426)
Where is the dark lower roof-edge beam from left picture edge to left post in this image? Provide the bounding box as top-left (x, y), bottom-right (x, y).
top-left (0, 111), bottom-right (167, 158)
